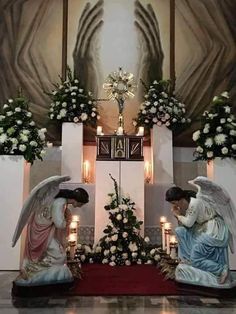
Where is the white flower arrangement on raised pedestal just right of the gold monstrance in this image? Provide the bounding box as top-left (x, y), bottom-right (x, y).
top-left (133, 80), bottom-right (191, 131)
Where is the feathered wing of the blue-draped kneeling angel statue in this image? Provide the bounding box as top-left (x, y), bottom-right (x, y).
top-left (189, 176), bottom-right (236, 237)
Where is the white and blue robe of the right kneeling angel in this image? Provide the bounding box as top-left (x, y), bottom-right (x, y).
top-left (175, 198), bottom-right (229, 276)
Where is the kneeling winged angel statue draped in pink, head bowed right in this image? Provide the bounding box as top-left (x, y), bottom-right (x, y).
top-left (12, 176), bottom-right (89, 286)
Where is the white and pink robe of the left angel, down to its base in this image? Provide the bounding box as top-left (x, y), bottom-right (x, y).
top-left (17, 198), bottom-right (72, 285)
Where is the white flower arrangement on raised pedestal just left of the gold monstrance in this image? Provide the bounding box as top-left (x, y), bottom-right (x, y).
top-left (47, 68), bottom-right (100, 127)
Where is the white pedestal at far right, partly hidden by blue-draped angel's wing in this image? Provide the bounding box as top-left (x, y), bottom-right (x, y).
top-left (207, 158), bottom-right (236, 270)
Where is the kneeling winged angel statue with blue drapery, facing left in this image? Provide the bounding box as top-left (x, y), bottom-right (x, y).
top-left (166, 176), bottom-right (236, 288)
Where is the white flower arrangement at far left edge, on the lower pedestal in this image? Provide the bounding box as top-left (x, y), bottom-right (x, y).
top-left (0, 95), bottom-right (46, 164)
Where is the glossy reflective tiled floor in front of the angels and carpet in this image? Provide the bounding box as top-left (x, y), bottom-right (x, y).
top-left (0, 272), bottom-right (236, 314)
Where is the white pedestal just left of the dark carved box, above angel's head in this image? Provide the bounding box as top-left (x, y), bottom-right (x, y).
top-left (61, 122), bottom-right (83, 183)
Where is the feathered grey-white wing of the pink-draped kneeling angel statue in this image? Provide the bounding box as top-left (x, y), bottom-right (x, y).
top-left (12, 176), bottom-right (70, 247)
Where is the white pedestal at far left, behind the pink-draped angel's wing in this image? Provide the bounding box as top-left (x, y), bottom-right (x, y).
top-left (0, 155), bottom-right (30, 270)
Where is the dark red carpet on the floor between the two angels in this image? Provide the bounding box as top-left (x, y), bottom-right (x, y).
top-left (66, 264), bottom-right (178, 296)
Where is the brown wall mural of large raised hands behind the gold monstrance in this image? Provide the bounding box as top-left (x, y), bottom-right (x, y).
top-left (0, 0), bottom-right (236, 146)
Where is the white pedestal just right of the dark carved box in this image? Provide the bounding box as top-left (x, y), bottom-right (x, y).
top-left (151, 125), bottom-right (174, 184)
